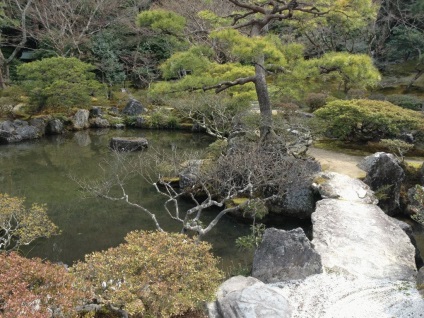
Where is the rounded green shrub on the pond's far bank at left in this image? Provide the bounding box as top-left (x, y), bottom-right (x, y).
top-left (17, 57), bottom-right (101, 109)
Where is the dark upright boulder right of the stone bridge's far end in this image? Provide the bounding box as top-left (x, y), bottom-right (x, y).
top-left (358, 152), bottom-right (405, 215)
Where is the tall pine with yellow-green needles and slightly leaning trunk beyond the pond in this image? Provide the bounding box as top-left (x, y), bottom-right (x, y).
top-left (146, 0), bottom-right (379, 140)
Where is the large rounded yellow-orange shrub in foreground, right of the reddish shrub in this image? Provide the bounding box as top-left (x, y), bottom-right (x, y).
top-left (73, 231), bottom-right (222, 317)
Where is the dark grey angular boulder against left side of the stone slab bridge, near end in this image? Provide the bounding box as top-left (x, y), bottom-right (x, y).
top-left (252, 228), bottom-right (322, 283)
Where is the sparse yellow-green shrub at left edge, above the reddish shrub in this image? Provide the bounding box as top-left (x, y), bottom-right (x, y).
top-left (0, 193), bottom-right (58, 252)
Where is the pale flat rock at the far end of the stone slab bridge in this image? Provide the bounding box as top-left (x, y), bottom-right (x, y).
top-left (312, 172), bottom-right (378, 204)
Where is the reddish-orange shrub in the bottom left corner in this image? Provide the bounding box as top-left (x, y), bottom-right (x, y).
top-left (0, 253), bottom-right (89, 318)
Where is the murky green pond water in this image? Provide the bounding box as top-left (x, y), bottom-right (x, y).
top-left (0, 130), bottom-right (258, 268)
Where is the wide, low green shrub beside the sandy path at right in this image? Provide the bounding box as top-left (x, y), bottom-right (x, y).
top-left (315, 99), bottom-right (424, 142)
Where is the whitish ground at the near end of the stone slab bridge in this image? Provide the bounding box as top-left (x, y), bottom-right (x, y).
top-left (271, 273), bottom-right (424, 318)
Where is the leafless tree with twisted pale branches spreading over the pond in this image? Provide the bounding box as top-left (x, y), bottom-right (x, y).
top-left (76, 138), bottom-right (316, 239)
